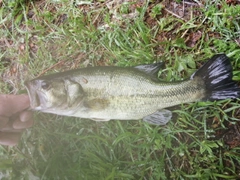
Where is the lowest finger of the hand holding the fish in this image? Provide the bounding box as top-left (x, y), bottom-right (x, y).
top-left (0, 132), bottom-right (21, 146)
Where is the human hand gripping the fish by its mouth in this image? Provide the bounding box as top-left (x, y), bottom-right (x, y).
top-left (0, 94), bottom-right (33, 146)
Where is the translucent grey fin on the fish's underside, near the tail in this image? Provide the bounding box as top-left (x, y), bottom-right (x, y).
top-left (143, 109), bottom-right (172, 125)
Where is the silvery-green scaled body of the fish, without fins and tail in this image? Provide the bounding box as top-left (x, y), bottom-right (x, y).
top-left (24, 67), bottom-right (204, 119)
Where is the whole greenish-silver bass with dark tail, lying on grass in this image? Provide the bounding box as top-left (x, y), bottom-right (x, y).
top-left (25, 54), bottom-right (240, 125)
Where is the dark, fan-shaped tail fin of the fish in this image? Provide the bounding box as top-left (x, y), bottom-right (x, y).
top-left (191, 54), bottom-right (240, 100)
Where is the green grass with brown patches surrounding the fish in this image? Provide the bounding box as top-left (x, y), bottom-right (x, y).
top-left (0, 0), bottom-right (240, 180)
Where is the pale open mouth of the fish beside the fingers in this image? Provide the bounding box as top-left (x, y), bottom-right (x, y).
top-left (24, 81), bottom-right (41, 110)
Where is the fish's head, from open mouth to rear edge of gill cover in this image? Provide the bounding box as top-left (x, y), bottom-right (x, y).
top-left (25, 78), bottom-right (84, 112)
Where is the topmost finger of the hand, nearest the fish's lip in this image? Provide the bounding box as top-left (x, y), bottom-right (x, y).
top-left (0, 94), bottom-right (30, 116)
